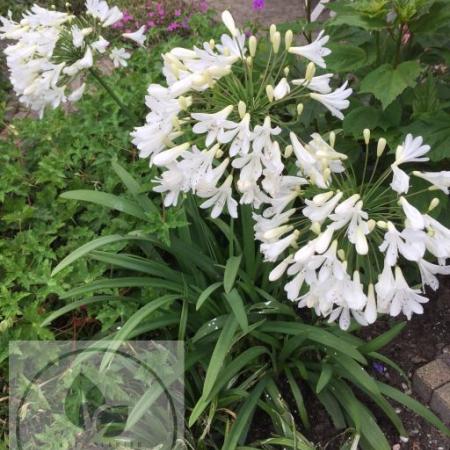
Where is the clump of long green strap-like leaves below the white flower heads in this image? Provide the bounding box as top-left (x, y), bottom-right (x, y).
top-left (43, 164), bottom-right (449, 450)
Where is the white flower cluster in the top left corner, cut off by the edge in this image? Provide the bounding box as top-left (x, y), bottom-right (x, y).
top-left (0, 0), bottom-right (143, 117)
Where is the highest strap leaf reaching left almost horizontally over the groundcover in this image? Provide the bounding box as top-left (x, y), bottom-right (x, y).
top-left (60, 189), bottom-right (146, 220)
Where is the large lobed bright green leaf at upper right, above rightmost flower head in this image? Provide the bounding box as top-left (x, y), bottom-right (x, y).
top-left (360, 61), bottom-right (422, 109)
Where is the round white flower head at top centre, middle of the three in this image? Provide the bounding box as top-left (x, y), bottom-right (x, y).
top-left (132, 11), bottom-right (352, 217)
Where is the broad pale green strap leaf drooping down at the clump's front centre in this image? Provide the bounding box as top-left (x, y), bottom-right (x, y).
top-left (202, 315), bottom-right (238, 398)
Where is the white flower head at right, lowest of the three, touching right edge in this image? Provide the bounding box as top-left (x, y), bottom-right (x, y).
top-left (255, 130), bottom-right (450, 329)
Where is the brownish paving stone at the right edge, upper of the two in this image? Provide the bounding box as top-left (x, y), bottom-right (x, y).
top-left (413, 359), bottom-right (450, 403)
